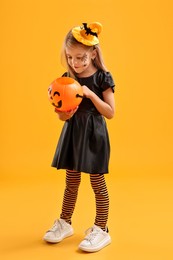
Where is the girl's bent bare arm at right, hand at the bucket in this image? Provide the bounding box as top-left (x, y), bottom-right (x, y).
top-left (82, 86), bottom-right (115, 119)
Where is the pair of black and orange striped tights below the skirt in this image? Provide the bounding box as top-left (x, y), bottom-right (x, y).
top-left (60, 170), bottom-right (109, 230)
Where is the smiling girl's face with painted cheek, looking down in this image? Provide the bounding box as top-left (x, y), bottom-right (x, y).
top-left (65, 45), bottom-right (96, 75)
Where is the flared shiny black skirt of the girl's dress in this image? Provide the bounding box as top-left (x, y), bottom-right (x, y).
top-left (52, 110), bottom-right (110, 174)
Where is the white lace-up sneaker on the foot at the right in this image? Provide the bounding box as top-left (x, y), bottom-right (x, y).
top-left (79, 225), bottom-right (111, 252)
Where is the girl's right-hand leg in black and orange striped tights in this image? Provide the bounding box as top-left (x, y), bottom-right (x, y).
top-left (90, 174), bottom-right (109, 231)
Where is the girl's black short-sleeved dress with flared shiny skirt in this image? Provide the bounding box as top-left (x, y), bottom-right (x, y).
top-left (52, 70), bottom-right (115, 174)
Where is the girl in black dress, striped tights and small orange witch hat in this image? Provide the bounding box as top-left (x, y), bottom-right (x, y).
top-left (44, 23), bottom-right (115, 252)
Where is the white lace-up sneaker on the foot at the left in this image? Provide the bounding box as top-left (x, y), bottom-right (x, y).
top-left (43, 219), bottom-right (74, 243)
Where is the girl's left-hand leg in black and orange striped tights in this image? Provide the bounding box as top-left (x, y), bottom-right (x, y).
top-left (60, 170), bottom-right (81, 224)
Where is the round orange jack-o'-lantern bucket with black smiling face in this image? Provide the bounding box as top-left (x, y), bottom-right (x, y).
top-left (48, 77), bottom-right (83, 111)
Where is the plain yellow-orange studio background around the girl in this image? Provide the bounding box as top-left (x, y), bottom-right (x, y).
top-left (0, 0), bottom-right (173, 260)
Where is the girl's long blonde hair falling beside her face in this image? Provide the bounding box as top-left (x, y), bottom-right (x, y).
top-left (61, 30), bottom-right (107, 78)
